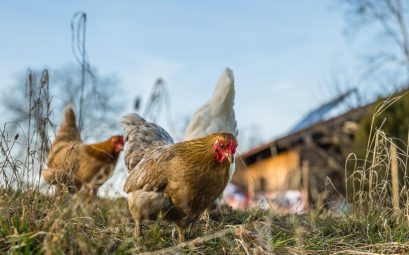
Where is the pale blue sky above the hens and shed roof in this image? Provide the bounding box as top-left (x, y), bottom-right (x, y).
top-left (0, 0), bottom-right (358, 145)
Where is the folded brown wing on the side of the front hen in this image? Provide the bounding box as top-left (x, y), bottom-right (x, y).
top-left (124, 145), bottom-right (174, 193)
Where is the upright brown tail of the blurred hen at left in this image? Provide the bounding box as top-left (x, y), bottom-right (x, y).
top-left (54, 104), bottom-right (81, 143)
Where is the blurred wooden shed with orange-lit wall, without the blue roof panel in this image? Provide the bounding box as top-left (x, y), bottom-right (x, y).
top-left (233, 103), bottom-right (368, 205)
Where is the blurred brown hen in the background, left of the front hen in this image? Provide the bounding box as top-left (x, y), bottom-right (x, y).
top-left (41, 105), bottom-right (124, 195)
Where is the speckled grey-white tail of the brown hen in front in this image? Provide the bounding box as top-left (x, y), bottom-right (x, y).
top-left (121, 114), bottom-right (173, 171)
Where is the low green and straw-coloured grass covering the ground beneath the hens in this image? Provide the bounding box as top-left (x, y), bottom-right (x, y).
top-left (0, 189), bottom-right (409, 254)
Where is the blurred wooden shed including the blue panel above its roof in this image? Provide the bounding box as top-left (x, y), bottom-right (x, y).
top-left (233, 91), bottom-right (369, 212)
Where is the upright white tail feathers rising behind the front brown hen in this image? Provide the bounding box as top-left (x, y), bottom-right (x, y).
top-left (184, 68), bottom-right (238, 141)
